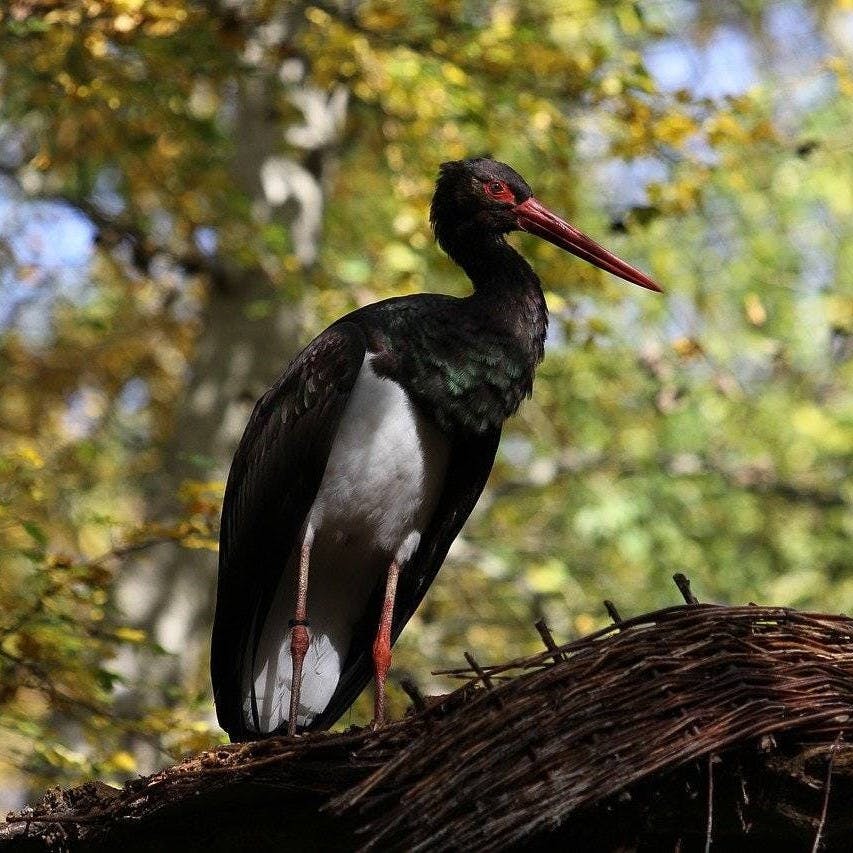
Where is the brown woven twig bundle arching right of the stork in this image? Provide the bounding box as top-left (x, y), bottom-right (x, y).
top-left (335, 605), bottom-right (853, 850)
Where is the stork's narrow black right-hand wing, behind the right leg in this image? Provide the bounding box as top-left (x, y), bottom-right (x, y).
top-left (308, 429), bottom-right (501, 729)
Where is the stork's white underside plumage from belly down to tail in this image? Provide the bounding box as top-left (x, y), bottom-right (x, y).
top-left (243, 354), bottom-right (449, 732)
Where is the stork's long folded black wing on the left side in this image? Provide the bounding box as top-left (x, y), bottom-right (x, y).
top-left (210, 322), bottom-right (367, 740)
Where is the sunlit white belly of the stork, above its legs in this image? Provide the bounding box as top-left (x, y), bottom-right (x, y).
top-left (310, 353), bottom-right (449, 562)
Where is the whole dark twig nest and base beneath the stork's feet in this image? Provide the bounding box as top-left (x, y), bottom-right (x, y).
top-left (5, 588), bottom-right (853, 851)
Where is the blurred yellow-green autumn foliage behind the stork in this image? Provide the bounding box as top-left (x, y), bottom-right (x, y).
top-left (0, 0), bottom-right (853, 800)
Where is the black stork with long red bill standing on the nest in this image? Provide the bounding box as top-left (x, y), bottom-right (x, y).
top-left (211, 158), bottom-right (660, 740)
